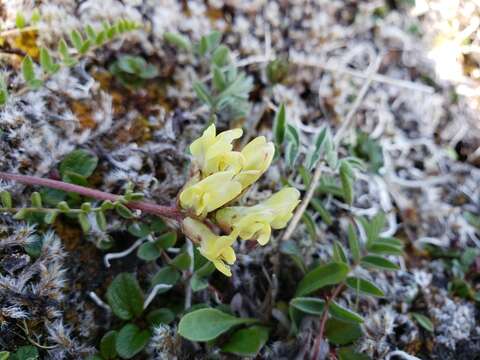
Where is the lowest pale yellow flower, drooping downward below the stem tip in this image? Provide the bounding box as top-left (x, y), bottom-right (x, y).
top-left (182, 217), bottom-right (236, 276)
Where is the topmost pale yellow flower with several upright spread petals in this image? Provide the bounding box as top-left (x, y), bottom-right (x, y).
top-left (190, 124), bottom-right (243, 178)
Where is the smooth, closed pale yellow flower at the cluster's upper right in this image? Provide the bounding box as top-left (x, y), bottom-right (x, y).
top-left (236, 136), bottom-right (275, 189)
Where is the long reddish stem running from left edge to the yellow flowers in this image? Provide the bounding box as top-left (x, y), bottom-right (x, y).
top-left (0, 171), bottom-right (183, 221)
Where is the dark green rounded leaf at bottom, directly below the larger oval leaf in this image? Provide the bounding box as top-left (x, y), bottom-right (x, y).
top-left (115, 324), bottom-right (152, 359)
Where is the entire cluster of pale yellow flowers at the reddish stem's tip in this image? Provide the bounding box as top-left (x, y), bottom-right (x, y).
top-left (179, 125), bottom-right (300, 276)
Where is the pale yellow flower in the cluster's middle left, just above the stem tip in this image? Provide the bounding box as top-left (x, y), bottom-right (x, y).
top-left (180, 171), bottom-right (242, 217)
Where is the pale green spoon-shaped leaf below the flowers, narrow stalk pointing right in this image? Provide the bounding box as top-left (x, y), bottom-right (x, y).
top-left (178, 308), bottom-right (257, 341)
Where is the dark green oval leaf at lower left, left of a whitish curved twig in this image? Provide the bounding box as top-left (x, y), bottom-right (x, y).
top-left (107, 273), bottom-right (143, 320)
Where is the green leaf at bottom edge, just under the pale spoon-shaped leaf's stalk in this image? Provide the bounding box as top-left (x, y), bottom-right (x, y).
top-left (222, 325), bottom-right (268, 357)
